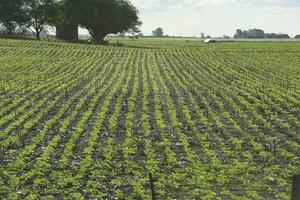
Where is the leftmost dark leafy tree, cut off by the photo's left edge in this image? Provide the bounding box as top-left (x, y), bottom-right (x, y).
top-left (0, 0), bottom-right (27, 34)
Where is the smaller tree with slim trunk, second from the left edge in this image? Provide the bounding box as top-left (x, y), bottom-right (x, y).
top-left (26, 0), bottom-right (55, 40)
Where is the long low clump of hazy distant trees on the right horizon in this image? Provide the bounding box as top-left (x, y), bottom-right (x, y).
top-left (234, 29), bottom-right (290, 38)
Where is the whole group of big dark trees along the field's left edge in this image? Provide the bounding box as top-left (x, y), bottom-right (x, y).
top-left (0, 0), bottom-right (141, 43)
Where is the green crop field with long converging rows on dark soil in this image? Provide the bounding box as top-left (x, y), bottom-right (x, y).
top-left (0, 39), bottom-right (300, 200)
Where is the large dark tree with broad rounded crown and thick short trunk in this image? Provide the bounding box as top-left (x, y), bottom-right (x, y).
top-left (66, 0), bottom-right (141, 44)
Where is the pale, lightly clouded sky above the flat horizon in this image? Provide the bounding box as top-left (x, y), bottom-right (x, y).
top-left (131, 0), bottom-right (300, 37)
